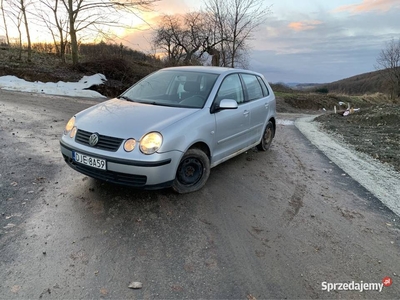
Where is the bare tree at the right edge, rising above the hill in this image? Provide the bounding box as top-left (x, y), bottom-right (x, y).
top-left (375, 39), bottom-right (400, 99)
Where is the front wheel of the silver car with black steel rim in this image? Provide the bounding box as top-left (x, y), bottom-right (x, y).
top-left (172, 148), bottom-right (210, 194)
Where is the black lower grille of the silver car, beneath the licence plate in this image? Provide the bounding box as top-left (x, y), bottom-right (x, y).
top-left (64, 155), bottom-right (147, 187)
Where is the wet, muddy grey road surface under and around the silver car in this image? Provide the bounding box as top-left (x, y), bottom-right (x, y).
top-left (0, 90), bottom-right (400, 299)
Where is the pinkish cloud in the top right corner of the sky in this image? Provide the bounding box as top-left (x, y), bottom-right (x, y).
top-left (334, 0), bottom-right (400, 14)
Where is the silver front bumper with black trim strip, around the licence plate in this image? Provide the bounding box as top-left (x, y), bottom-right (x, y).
top-left (60, 140), bottom-right (182, 189)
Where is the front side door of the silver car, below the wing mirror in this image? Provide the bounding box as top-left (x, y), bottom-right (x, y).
top-left (212, 74), bottom-right (250, 163)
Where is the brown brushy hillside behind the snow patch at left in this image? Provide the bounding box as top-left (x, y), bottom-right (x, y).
top-left (0, 43), bottom-right (164, 97)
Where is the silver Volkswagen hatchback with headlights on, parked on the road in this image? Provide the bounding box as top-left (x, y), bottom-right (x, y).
top-left (60, 67), bottom-right (276, 193)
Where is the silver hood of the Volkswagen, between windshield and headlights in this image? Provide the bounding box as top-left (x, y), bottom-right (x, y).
top-left (76, 98), bottom-right (199, 139)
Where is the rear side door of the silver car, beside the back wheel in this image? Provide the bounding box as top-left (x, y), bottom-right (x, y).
top-left (241, 74), bottom-right (272, 143)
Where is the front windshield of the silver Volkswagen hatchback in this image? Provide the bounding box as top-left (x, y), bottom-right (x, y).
top-left (119, 70), bottom-right (218, 108)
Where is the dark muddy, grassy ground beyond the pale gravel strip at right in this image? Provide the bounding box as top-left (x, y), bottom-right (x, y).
top-left (277, 97), bottom-right (400, 171)
